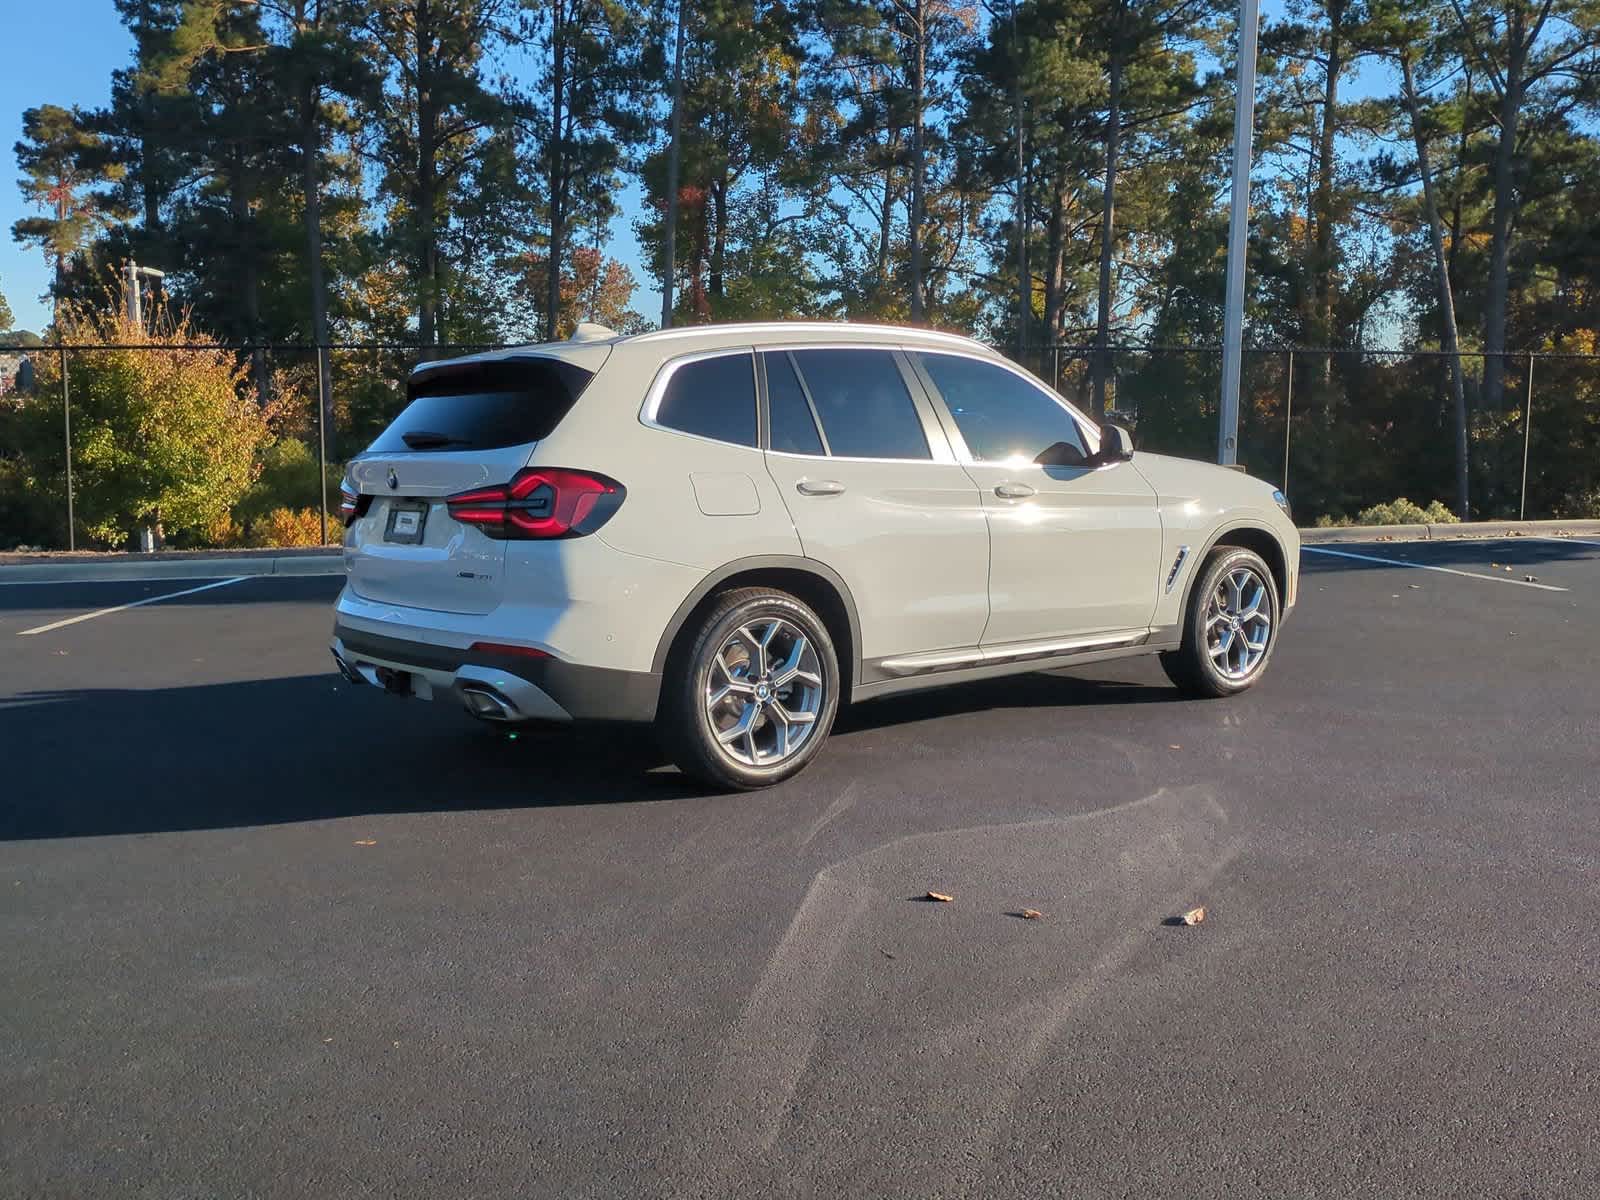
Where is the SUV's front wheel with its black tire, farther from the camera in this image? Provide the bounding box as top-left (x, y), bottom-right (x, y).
top-left (1162, 546), bottom-right (1280, 698)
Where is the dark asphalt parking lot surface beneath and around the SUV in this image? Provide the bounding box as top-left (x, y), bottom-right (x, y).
top-left (0, 539), bottom-right (1600, 1197)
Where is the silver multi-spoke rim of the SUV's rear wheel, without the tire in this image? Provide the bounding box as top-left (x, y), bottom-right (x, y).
top-left (706, 616), bottom-right (824, 766)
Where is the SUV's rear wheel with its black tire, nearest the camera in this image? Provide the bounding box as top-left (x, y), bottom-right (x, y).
top-left (656, 587), bottom-right (840, 790)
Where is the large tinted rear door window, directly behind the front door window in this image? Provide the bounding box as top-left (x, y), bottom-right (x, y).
top-left (792, 349), bottom-right (933, 459)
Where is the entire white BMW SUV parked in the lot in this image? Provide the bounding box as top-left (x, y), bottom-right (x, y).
top-left (333, 323), bottom-right (1299, 787)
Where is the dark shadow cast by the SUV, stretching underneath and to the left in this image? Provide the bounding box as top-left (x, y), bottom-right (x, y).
top-left (0, 672), bottom-right (1176, 842)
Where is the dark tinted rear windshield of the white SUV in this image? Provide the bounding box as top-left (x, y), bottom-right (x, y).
top-left (368, 358), bottom-right (594, 454)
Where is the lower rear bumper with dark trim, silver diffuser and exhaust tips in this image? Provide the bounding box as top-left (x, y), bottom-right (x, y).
top-left (331, 621), bottom-right (661, 722)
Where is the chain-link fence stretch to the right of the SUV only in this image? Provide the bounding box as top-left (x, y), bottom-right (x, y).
top-left (1026, 346), bottom-right (1600, 525)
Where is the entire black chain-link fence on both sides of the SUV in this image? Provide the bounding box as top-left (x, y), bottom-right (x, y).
top-left (0, 334), bottom-right (1600, 550)
